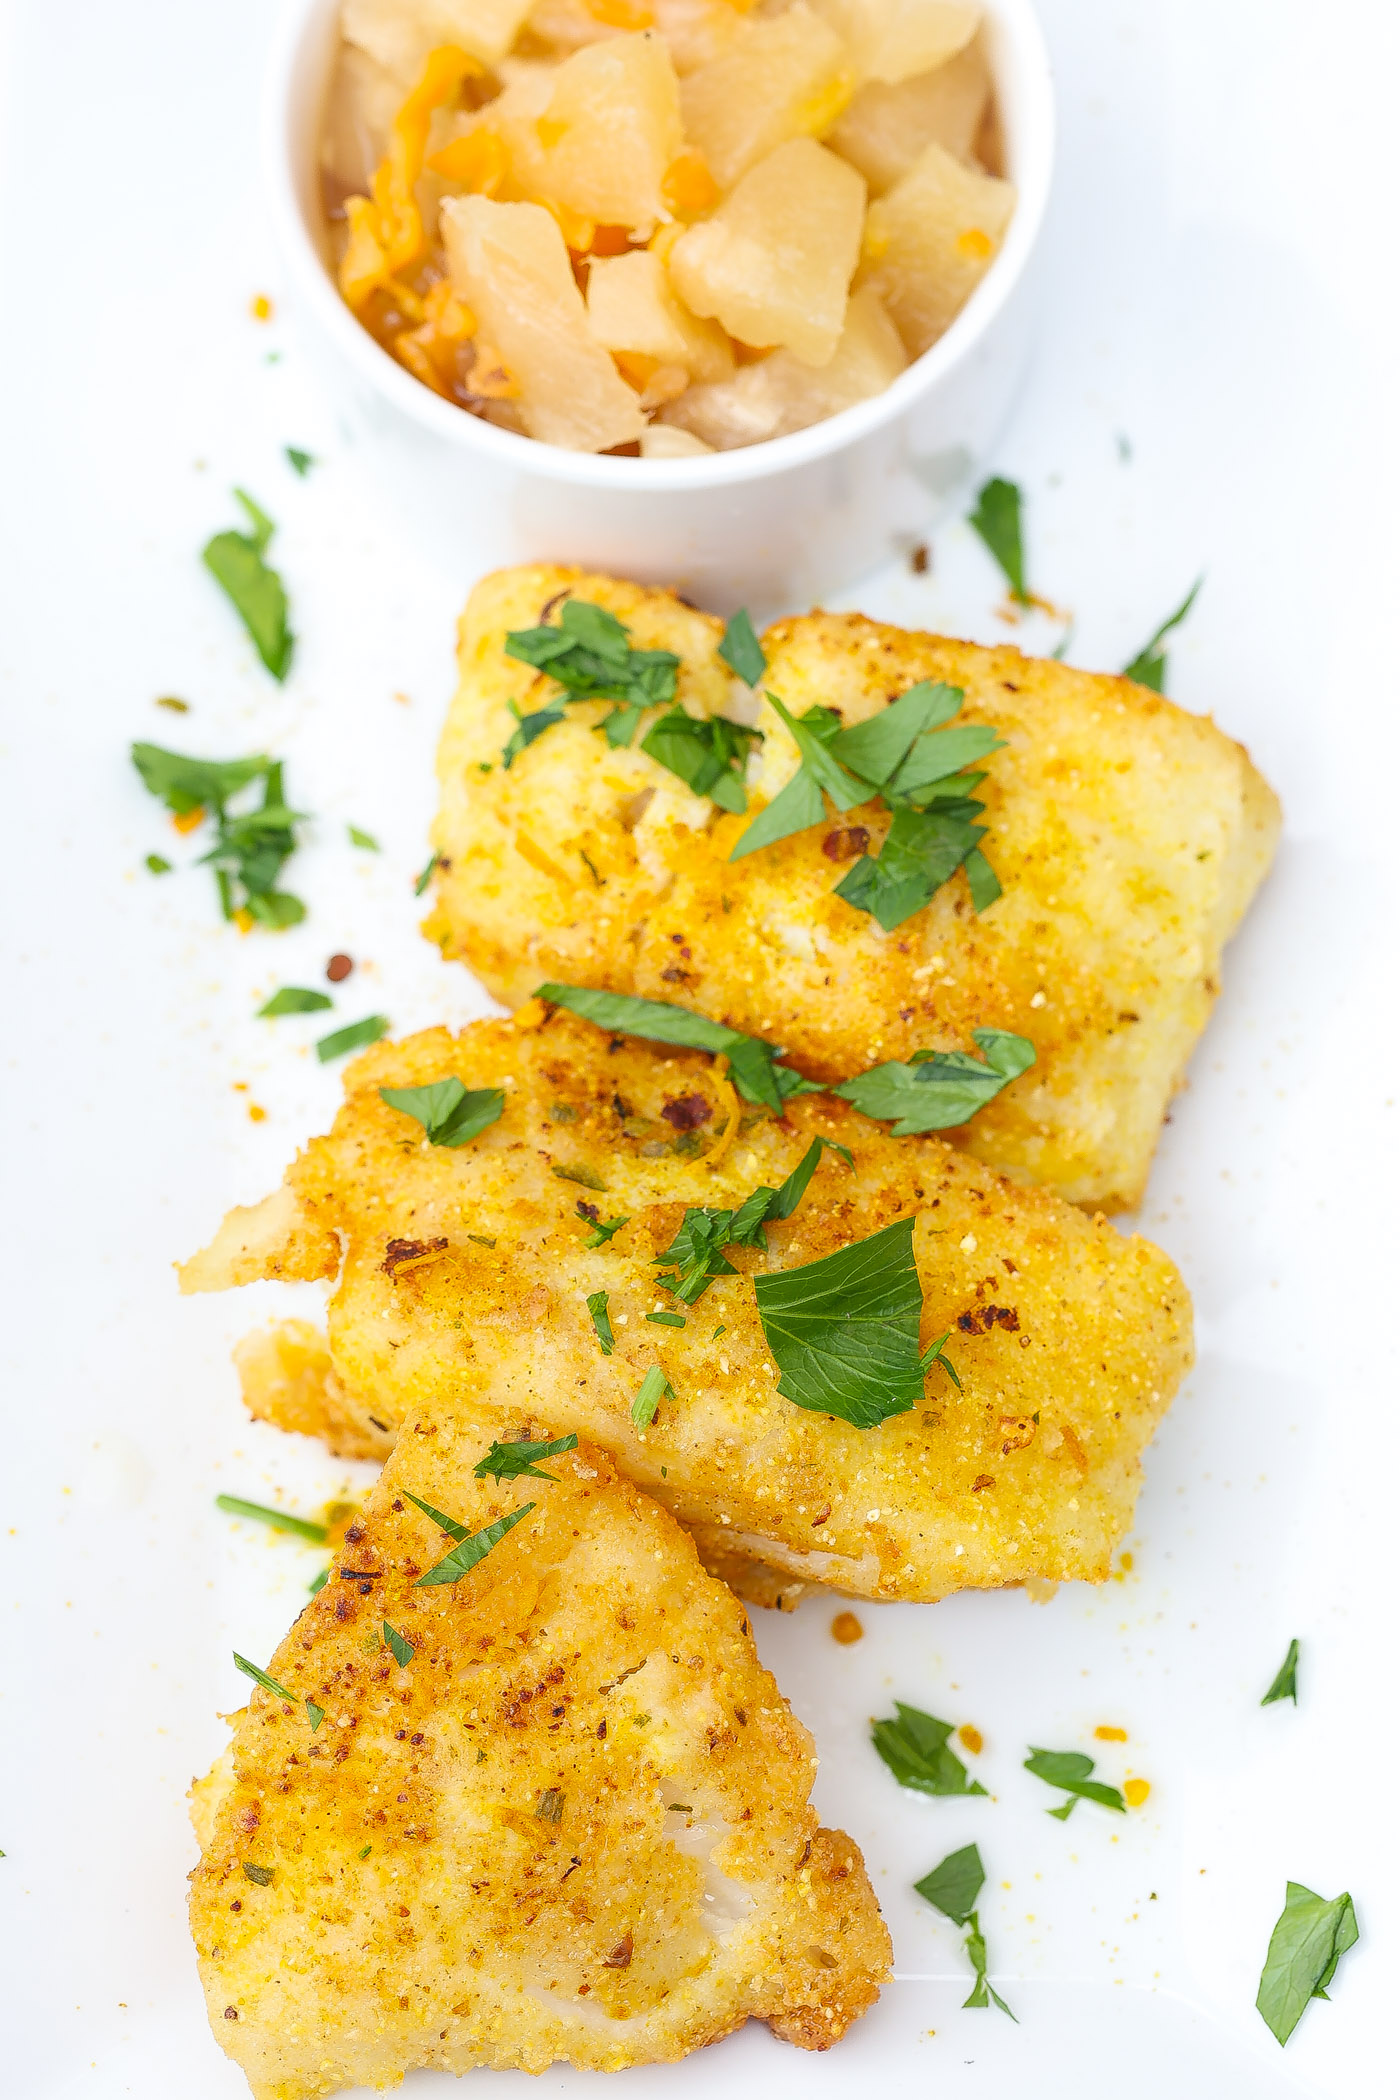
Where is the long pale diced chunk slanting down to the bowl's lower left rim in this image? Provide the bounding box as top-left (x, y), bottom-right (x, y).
top-left (441, 197), bottom-right (646, 452)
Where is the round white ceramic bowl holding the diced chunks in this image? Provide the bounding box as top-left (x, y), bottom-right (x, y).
top-left (267, 0), bottom-right (1054, 611)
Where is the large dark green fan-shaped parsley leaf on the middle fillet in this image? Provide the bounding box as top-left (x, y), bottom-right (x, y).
top-left (754, 1218), bottom-right (951, 1430)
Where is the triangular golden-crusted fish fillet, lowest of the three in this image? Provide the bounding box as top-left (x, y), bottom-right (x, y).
top-left (191, 1415), bottom-right (890, 2100)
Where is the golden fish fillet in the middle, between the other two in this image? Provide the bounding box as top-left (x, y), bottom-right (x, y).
top-left (181, 1010), bottom-right (1190, 1598)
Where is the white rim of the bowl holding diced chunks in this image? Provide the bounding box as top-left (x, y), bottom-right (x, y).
top-left (262, 0), bottom-right (1056, 496)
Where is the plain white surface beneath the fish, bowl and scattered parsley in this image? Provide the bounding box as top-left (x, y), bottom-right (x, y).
top-left (0, 0), bottom-right (1400, 2100)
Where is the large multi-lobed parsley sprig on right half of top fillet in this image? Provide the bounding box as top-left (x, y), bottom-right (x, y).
top-left (730, 680), bottom-right (1001, 932)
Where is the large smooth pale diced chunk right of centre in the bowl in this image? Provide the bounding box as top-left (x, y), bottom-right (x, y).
top-left (670, 138), bottom-right (865, 365)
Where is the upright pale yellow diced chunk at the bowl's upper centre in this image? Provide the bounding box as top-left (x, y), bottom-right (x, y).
top-left (535, 29), bottom-right (682, 227)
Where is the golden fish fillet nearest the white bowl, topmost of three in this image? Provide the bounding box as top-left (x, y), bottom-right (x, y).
top-left (424, 567), bottom-right (1278, 1210)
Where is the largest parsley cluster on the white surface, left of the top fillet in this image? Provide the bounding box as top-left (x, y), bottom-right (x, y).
top-left (132, 743), bottom-right (306, 930)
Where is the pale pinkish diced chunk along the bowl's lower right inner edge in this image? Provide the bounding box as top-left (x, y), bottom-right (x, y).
top-left (667, 290), bottom-right (909, 445)
